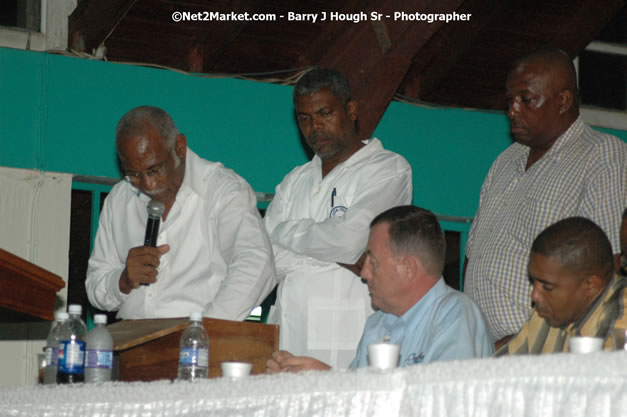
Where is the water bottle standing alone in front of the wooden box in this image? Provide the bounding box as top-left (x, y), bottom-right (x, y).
top-left (178, 311), bottom-right (209, 381)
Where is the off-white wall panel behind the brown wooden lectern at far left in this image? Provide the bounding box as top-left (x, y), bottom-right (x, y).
top-left (0, 167), bottom-right (72, 386)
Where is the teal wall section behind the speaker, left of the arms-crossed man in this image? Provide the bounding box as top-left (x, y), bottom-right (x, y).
top-left (0, 48), bottom-right (307, 197)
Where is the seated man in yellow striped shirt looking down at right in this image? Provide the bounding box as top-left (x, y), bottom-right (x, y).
top-left (496, 217), bottom-right (627, 356)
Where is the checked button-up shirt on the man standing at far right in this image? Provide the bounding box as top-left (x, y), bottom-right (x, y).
top-left (465, 118), bottom-right (627, 340)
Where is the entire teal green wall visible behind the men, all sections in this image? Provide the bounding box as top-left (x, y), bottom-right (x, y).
top-left (0, 48), bottom-right (627, 217)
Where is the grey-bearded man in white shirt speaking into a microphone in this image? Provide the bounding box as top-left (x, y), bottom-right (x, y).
top-left (86, 106), bottom-right (275, 320)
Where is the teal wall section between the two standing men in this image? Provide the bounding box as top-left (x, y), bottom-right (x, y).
top-left (375, 102), bottom-right (511, 217)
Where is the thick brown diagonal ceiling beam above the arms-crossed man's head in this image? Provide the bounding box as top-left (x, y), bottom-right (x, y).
top-left (308, 0), bottom-right (463, 137)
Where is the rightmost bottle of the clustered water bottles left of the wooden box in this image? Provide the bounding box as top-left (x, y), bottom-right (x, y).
top-left (85, 314), bottom-right (113, 382)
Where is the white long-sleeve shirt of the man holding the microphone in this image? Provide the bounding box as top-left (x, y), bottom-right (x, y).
top-left (85, 149), bottom-right (276, 320)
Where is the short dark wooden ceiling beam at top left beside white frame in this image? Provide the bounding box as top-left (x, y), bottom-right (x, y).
top-left (68, 0), bottom-right (137, 53)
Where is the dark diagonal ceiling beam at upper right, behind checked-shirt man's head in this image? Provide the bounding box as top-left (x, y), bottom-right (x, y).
top-left (422, 0), bottom-right (627, 110)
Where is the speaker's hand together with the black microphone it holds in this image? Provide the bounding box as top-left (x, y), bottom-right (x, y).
top-left (119, 200), bottom-right (170, 294)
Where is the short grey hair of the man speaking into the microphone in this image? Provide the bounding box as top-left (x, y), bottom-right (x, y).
top-left (115, 106), bottom-right (179, 149)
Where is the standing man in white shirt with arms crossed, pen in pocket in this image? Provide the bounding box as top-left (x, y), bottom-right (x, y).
top-left (264, 69), bottom-right (412, 367)
